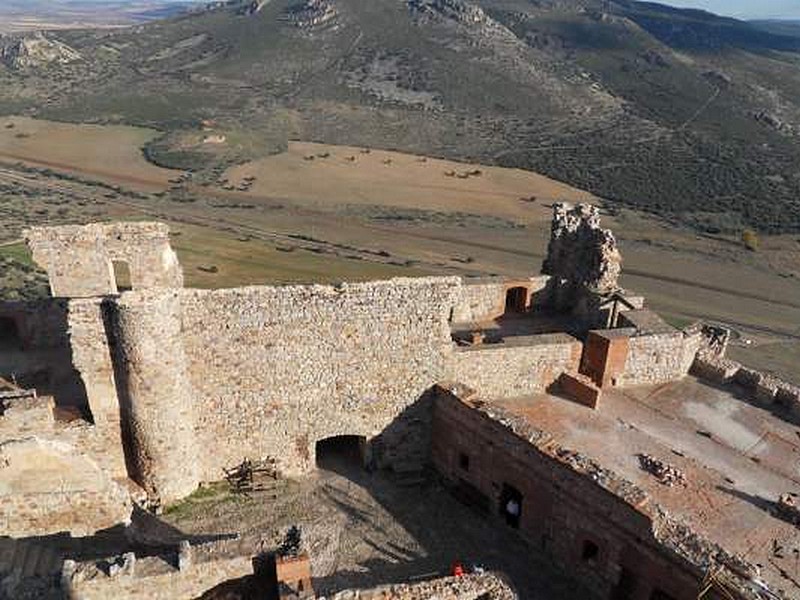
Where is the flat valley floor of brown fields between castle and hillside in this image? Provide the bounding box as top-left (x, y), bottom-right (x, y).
top-left (0, 118), bottom-right (800, 380)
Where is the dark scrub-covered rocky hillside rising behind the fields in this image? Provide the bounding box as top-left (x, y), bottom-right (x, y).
top-left (0, 0), bottom-right (800, 232)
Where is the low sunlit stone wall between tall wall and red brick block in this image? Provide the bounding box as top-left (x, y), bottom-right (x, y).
top-left (447, 333), bottom-right (583, 398)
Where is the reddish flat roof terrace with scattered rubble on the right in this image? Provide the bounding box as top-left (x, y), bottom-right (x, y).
top-left (486, 377), bottom-right (800, 596)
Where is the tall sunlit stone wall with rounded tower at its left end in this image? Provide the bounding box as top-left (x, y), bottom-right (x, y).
top-left (114, 278), bottom-right (459, 490)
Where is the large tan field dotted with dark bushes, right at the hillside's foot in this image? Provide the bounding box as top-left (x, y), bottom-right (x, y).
top-left (225, 142), bottom-right (593, 223)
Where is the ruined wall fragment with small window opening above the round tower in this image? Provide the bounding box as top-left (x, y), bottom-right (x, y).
top-left (24, 222), bottom-right (183, 298)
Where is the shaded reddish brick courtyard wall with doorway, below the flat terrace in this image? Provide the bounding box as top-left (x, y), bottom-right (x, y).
top-left (432, 395), bottom-right (699, 600)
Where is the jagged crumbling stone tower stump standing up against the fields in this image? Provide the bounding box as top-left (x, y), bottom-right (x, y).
top-left (542, 203), bottom-right (622, 294)
